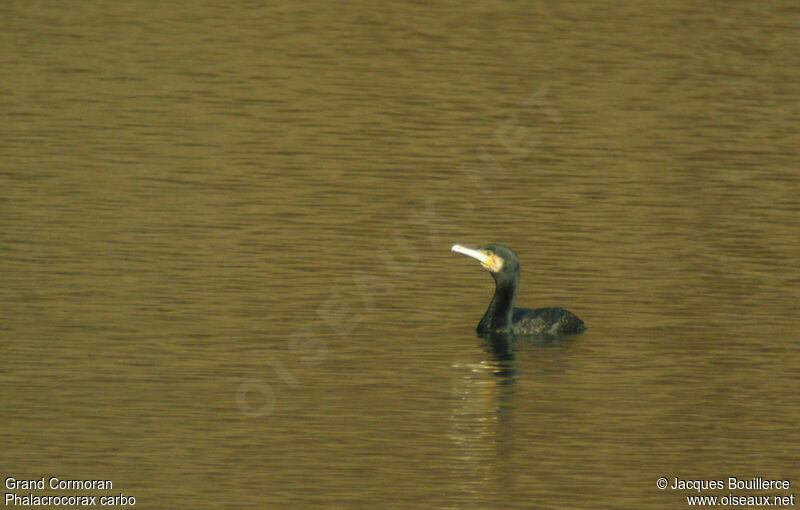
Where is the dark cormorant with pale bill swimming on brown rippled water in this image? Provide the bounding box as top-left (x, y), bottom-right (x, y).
top-left (451, 243), bottom-right (586, 336)
